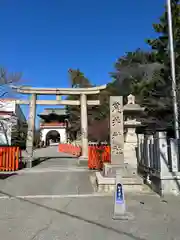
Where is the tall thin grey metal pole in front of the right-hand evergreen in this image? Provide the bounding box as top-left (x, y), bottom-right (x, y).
top-left (167, 0), bottom-right (179, 139)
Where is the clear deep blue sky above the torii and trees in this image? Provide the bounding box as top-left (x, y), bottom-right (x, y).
top-left (0, 0), bottom-right (165, 125)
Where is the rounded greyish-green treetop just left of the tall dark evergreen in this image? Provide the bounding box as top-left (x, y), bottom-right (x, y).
top-left (111, 49), bottom-right (161, 99)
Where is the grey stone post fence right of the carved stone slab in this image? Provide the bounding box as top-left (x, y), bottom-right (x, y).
top-left (137, 132), bottom-right (180, 178)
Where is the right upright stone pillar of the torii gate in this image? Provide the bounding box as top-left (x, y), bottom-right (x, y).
top-left (80, 94), bottom-right (88, 160)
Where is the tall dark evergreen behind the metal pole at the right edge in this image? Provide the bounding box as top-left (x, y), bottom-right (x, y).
top-left (141, 0), bottom-right (180, 126)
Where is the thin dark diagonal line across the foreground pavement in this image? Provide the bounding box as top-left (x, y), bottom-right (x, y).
top-left (0, 191), bottom-right (146, 240)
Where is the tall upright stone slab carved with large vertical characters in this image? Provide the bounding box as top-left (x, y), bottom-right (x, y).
top-left (110, 96), bottom-right (124, 165)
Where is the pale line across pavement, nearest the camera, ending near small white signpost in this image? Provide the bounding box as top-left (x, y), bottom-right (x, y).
top-left (0, 193), bottom-right (112, 200)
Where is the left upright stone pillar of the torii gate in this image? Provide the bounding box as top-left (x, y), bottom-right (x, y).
top-left (26, 94), bottom-right (36, 168)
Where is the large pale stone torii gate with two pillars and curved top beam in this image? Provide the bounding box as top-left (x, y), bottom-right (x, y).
top-left (12, 85), bottom-right (106, 168)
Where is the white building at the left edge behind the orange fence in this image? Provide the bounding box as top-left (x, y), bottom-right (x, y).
top-left (0, 99), bottom-right (27, 147)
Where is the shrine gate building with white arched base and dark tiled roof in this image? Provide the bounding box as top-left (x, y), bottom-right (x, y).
top-left (38, 108), bottom-right (68, 146)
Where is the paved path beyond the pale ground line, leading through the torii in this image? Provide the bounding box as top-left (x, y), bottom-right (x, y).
top-left (0, 146), bottom-right (95, 198)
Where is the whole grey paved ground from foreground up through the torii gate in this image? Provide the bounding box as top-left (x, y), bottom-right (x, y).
top-left (0, 145), bottom-right (180, 240)
